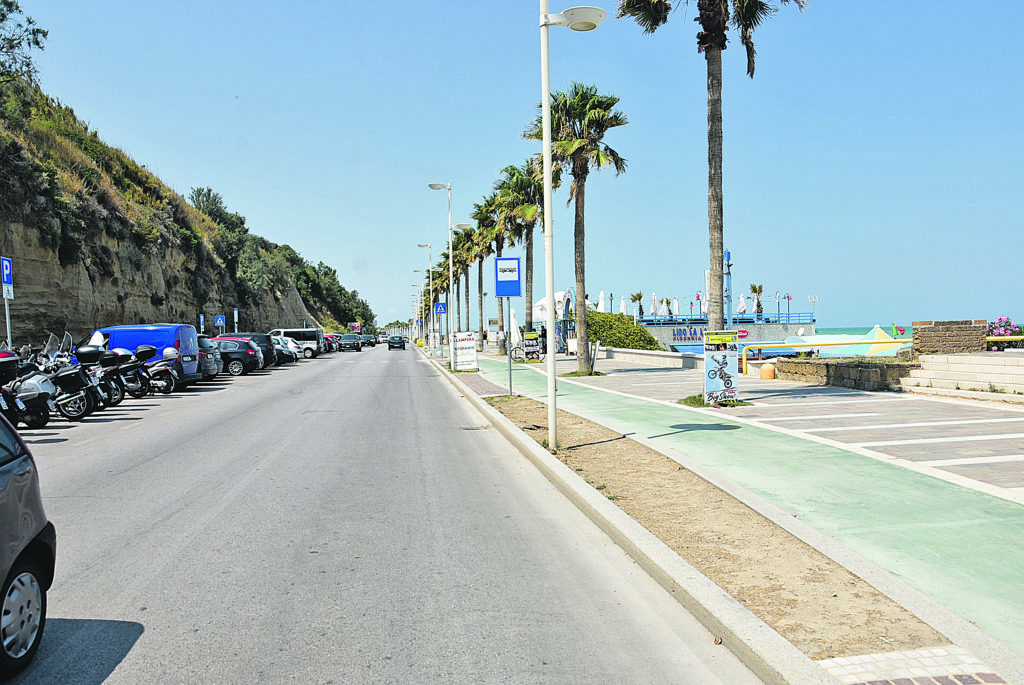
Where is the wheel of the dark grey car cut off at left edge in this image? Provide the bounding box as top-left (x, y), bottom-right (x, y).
top-left (0, 560), bottom-right (46, 678)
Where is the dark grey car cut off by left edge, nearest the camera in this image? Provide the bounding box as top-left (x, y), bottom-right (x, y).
top-left (0, 416), bottom-right (57, 680)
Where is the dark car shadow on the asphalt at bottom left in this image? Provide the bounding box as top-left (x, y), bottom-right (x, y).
top-left (9, 618), bottom-right (145, 685)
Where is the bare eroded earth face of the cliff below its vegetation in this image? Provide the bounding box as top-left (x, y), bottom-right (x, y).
top-left (0, 222), bottom-right (314, 346)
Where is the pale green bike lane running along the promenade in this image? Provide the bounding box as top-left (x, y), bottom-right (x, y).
top-left (479, 357), bottom-right (1024, 656)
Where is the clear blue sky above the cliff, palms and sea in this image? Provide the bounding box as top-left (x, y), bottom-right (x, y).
top-left (22, 0), bottom-right (1024, 327)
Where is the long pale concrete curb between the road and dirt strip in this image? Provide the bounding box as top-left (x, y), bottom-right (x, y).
top-left (427, 357), bottom-right (837, 685)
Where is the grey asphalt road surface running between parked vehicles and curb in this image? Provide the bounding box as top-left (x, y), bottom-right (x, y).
top-left (15, 346), bottom-right (756, 685)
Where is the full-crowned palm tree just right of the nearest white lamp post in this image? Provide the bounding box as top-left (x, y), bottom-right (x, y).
top-left (523, 82), bottom-right (629, 374)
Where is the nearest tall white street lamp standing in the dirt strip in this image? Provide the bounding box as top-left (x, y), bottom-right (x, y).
top-left (540, 0), bottom-right (607, 453)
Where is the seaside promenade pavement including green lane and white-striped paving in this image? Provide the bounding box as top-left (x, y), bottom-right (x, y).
top-left (456, 356), bottom-right (1024, 683)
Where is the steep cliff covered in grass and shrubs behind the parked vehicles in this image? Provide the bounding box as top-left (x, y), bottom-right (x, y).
top-left (0, 82), bottom-right (373, 345)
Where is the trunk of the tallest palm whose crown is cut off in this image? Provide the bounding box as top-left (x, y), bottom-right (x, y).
top-left (705, 47), bottom-right (725, 331)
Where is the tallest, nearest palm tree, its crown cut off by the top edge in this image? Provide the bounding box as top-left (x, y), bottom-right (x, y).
top-left (618, 0), bottom-right (807, 331)
